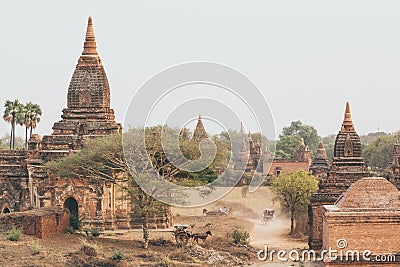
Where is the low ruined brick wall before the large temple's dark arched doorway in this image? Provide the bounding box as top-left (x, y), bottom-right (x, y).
top-left (0, 208), bottom-right (70, 238)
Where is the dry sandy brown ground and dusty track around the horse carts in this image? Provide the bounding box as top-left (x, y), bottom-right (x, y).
top-left (0, 187), bottom-right (306, 266)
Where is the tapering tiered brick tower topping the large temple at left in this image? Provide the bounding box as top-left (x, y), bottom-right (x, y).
top-left (41, 17), bottom-right (122, 160)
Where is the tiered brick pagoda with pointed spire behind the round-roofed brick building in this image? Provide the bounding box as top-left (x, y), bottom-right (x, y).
top-left (309, 102), bottom-right (369, 250)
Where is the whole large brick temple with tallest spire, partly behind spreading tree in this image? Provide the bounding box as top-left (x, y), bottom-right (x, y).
top-left (0, 17), bottom-right (172, 232)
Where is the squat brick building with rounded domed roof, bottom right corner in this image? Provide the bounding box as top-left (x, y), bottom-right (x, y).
top-left (322, 177), bottom-right (400, 267)
